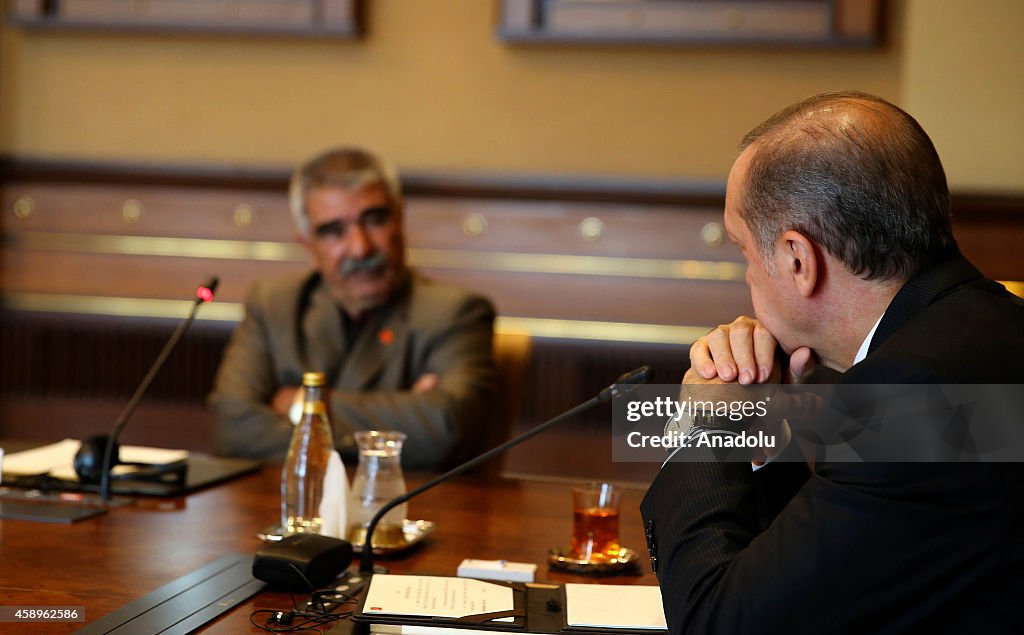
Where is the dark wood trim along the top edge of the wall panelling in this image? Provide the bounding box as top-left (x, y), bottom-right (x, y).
top-left (0, 157), bottom-right (1024, 214)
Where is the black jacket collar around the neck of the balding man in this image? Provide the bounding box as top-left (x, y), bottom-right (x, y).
top-left (867, 251), bottom-right (982, 354)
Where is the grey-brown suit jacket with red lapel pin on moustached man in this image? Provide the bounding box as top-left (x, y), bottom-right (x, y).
top-left (209, 273), bottom-right (495, 467)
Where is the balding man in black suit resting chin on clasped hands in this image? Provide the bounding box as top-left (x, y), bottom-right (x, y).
top-left (641, 92), bottom-right (1024, 633)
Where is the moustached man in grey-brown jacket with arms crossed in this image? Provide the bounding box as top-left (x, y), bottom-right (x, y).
top-left (210, 149), bottom-right (495, 467)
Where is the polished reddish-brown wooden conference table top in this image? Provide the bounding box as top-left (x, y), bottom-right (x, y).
top-left (0, 466), bottom-right (657, 633)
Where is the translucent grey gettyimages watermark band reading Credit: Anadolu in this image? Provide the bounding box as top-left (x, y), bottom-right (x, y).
top-left (612, 384), bottom-right (1024, 462)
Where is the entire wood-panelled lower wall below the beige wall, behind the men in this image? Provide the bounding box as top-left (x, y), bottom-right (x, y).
top-left (0, 161), bottom-right (1024, 479)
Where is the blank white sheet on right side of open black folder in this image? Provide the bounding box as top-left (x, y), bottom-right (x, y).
top-left (565, 584), bottom-right (668, 630)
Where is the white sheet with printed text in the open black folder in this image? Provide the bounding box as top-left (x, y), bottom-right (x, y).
top-left (362, 574), bottom-right (515, 618)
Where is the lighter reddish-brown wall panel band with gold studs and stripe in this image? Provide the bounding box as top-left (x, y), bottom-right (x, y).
top-left (2, 181), bottom-right (750, 326)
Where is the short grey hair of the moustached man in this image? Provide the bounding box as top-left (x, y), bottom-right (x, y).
top-left (288, 147), bottom-right (402, 238)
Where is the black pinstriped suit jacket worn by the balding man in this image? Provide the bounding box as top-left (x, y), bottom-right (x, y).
top-left (641, 256), bottom-right (1024, 633)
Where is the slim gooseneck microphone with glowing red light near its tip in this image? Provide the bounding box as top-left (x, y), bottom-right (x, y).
top-left (75, 276), bottom-right (220, 505)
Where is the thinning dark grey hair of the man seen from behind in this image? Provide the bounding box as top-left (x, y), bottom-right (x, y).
top-left (740, 91), bottom-right (955, 281)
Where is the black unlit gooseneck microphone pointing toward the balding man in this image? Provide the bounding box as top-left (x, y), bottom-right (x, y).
top-left (359, 366), bottom-right (651, 574)
